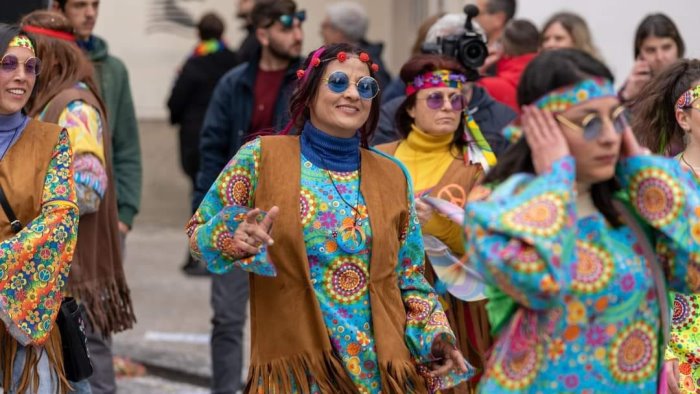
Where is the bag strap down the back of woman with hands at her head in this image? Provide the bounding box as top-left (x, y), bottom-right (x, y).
top-left (613, 200), bottom-right (671, 348)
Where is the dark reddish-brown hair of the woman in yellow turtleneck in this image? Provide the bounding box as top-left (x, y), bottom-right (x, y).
top-left (394, 54), bottom-right (467, 155)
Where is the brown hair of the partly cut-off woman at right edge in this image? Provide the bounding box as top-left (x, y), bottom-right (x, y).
top-left (632, 59), bottom-right (700, 154)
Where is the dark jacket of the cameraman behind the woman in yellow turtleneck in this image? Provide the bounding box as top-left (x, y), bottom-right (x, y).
top-left (370, 86), bottom-right (517, 156)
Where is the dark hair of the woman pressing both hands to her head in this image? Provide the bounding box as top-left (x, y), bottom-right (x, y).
top-left (484, 49), bottom-right (620, 226)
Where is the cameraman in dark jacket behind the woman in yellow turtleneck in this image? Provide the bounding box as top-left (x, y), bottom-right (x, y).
top-left (371, 10), bottom-right (516, 153)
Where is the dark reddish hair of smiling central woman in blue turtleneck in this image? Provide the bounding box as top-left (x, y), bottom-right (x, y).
top-left (280, 43), bottom-right (382, 148)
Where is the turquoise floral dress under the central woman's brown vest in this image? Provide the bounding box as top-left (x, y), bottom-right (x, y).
top-left (188, 139), bottom-right (473, 393)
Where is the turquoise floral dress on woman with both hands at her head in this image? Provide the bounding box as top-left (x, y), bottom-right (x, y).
top-left (465, 156), bottom-right (700, 393)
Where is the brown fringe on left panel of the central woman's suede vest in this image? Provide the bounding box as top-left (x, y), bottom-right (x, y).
top-left (245, 350), bottom-right (358, 394)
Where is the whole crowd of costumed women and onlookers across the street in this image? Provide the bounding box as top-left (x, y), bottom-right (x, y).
top-left (0, 0), bottom-right (700, 394)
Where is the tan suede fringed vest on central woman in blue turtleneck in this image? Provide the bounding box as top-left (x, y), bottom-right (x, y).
top-left (246, 136), bottom-right (426, 394)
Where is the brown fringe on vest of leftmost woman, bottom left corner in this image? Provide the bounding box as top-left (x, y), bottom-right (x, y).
top-left (0, 325), bottom-right (71, 394)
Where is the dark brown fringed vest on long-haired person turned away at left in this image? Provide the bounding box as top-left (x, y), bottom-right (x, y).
top-left (43, 88), bottom-right (136, 335)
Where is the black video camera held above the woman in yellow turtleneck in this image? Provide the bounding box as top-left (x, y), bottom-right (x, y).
top-left (421, 4), bottom-right (489, 71)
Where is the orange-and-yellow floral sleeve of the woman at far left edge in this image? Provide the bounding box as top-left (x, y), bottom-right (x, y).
top-left (0, 130), bottom-right (78, 346)
